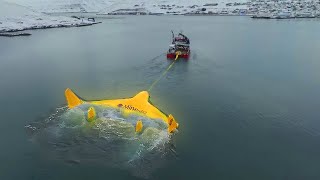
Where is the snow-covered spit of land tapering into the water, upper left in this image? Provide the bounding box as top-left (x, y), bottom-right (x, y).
top-left (0, 0), bottom-right (99, 32)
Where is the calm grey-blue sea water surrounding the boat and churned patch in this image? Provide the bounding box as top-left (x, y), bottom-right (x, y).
top-left (0, 16), bottom-right (320, 180)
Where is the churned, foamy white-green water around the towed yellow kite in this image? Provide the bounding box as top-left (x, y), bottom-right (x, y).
top-left (25, 104), bottom-right (176, 178)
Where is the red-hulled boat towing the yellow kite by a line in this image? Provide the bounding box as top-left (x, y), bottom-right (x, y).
top-left (167, 32), bottom-right (190, 59)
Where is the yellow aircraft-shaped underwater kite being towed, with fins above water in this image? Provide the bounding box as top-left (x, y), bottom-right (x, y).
top-left (65, 88), bottom-right (179, 133)
